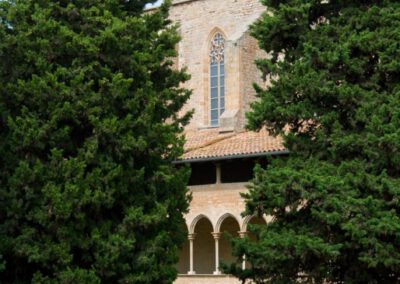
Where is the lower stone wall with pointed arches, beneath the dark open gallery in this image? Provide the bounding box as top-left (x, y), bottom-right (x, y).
top-left (177, 183), bottom-right (270, 278)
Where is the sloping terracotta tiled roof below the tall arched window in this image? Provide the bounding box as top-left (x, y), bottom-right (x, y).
top-left (182, 129), bottom-right (286, 161)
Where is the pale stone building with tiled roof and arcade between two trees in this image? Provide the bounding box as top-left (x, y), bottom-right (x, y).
top-left (148, 0), bottom-right (286, 284)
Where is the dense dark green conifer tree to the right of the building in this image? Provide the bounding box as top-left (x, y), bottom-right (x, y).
top-left (227, 0), bottom-right (400, 283)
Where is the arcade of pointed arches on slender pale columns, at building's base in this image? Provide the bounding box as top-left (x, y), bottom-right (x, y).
top-left (177, 213), bottom-right (268, 275)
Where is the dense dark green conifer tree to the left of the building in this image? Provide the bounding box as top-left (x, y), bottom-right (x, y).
top-left (0, 0), bottom-right (190, 283)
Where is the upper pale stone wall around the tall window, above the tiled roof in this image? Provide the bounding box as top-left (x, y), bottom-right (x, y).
top-left (170, 0), bottom-right (265, 129)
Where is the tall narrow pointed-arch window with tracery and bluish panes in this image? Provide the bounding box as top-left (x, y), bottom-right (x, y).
top-left (210, 33), bottom-right (225, 126)
